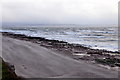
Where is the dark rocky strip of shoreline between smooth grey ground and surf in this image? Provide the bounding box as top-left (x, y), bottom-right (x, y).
top-left (2, 32), bottom-right (120, 67)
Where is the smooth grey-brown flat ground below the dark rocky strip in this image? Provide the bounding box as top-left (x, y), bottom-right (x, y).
top-left (2, 36), bottom-right (118, 78)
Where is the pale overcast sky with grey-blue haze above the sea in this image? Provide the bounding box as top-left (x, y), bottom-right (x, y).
top-left (0, 0), bottom-right (119, 24)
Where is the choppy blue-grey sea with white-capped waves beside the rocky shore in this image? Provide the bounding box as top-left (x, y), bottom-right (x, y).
top-left (1, 25), bottom-right (118, 51)
